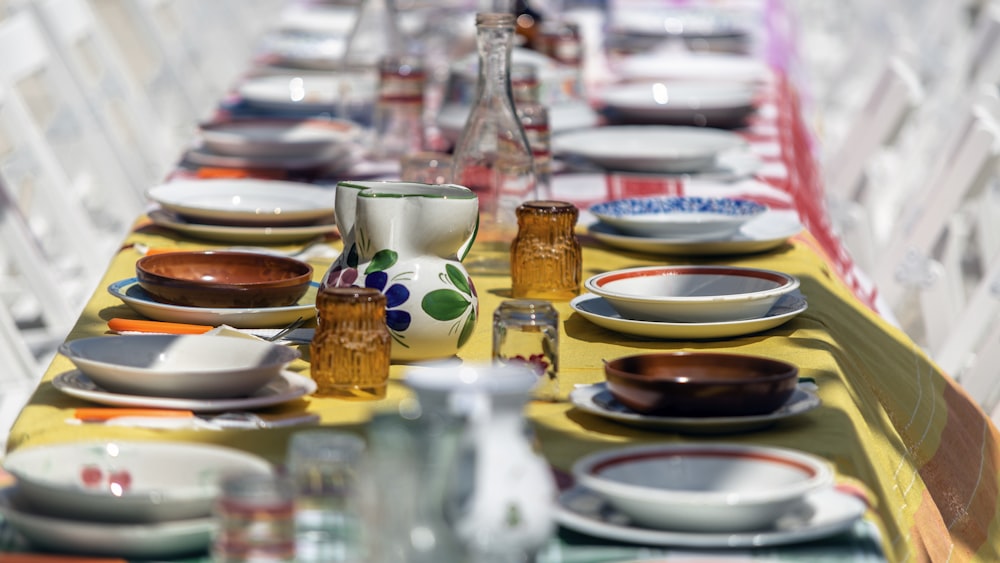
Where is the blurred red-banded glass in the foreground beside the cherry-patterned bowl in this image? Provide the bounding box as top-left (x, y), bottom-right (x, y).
top-left (212, 473), bottom-right (296, 563)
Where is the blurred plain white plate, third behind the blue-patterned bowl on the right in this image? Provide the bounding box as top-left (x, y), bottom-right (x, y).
top-left (612, 51), bottom-right (771, 83)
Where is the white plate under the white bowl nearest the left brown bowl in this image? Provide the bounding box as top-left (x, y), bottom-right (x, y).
top-left (52, 370), bottom-right (316, 412)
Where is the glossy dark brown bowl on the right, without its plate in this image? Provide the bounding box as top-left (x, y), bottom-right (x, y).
top-left (604, 352), bottom-right (799, 417)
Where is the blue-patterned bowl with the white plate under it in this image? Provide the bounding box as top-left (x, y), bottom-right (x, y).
top-left (587, 194), bottom-right (803, 256)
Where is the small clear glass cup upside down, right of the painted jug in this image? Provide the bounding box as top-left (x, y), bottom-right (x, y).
top-left (493, 299), bottom-right (559, 401)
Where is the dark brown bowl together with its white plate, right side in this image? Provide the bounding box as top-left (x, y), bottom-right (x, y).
top-left (569, 352), bottom-right (821, 435)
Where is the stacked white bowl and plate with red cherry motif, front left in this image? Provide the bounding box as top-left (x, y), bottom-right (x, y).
top-left (0, 441), bottom-right (273, 559)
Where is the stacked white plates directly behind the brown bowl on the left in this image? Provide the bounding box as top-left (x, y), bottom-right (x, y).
top-left (147, 178), bottom-right (336, 244)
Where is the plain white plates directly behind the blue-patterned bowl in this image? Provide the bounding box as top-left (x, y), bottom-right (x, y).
top-left (552, 125), bottom-right (764, 181)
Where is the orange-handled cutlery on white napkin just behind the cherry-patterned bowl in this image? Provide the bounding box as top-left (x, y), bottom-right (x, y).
top-left (71, 407), bottom-right (320, 430)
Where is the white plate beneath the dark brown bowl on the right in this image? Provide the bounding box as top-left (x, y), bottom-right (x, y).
top-left (569, 382), bottom-right (820, 434)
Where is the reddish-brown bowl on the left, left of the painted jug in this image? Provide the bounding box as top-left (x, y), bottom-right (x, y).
top-left (135, 250), bottom-right (313, 309)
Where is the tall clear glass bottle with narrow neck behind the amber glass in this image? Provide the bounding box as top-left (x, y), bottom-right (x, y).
top-left (452, 12), bottom-right (537, 274)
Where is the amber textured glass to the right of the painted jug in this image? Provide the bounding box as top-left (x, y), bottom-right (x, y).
top-left (510, 200), bottom-right (583, 300)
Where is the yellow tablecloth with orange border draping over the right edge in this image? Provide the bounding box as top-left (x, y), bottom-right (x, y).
top-left (9, 217), bottom-right (1000, 561)
